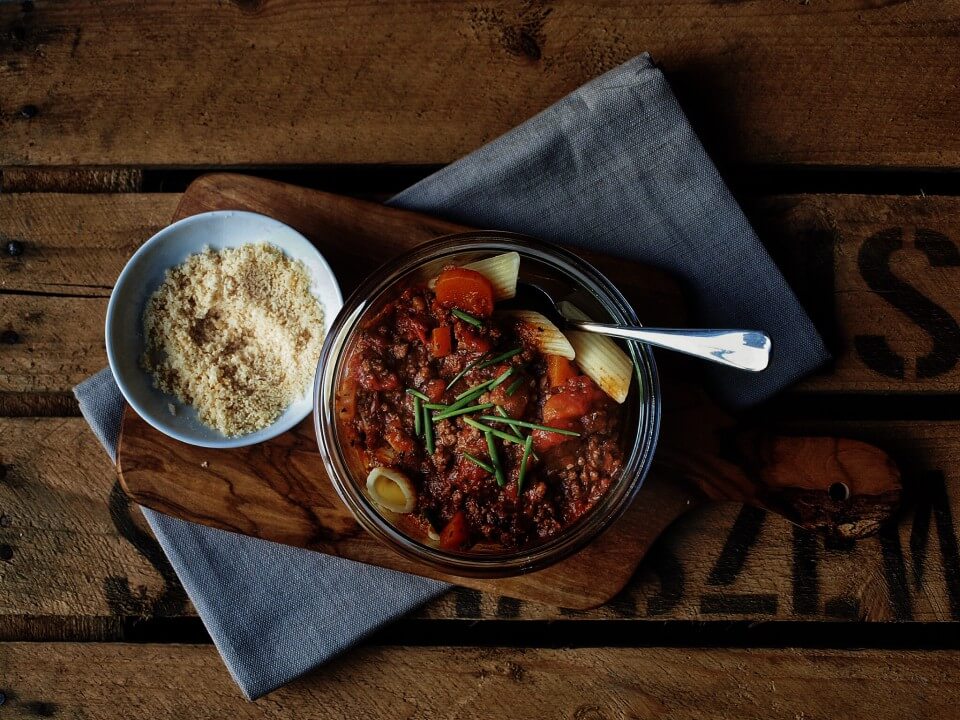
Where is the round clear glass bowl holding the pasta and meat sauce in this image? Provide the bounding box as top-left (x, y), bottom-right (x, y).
top-left (314, 231), bottom-right (660, 577)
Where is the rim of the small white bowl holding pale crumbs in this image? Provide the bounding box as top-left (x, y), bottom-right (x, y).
top-left (104, 210), bottom-right (343, 449)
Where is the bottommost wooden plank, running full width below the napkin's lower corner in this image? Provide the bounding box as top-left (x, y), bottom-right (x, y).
top-left (0, 643), bottom-right (960, 720)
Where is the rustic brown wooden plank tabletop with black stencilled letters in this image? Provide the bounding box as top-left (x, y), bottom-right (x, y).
top-left (0, 0), bottom-right (960, 720)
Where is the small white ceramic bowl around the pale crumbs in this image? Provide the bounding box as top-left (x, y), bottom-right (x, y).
top-left (106, 210), bottom-right (343, 448)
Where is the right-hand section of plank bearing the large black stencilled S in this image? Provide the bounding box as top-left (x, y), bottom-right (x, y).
top-left (750, 195), bottom-right (960, 393)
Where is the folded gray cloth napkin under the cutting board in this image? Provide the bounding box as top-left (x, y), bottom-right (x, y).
top-left (75, 55), bottom-right (828, 698)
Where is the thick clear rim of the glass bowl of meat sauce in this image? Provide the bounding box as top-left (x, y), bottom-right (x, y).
top-left (314, 230), bottom-right (661, 577)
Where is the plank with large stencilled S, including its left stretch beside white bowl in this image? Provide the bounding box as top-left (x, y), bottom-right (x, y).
top-left (0, 193), bottom-right (960, 393)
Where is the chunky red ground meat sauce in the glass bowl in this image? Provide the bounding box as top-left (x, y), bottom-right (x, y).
top-left (338, 269), bottom-right (623, 549)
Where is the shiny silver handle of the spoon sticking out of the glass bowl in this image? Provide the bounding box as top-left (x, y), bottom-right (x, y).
top-left (567, 320), bottom-right (771, 372)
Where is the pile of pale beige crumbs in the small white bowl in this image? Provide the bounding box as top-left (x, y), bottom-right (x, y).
top-left (141, 243), bottom-right (324, 436)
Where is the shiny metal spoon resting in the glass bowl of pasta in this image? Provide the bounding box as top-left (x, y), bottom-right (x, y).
top-left (511, 281), bottom-right (771, 372)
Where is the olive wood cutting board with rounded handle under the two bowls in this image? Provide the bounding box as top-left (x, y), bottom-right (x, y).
top-left (117, 174), bottom-right (901, 609)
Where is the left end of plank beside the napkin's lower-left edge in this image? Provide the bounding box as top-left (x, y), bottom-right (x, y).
top-left (0, 418), bottom-right (192, 637)
